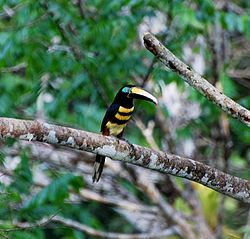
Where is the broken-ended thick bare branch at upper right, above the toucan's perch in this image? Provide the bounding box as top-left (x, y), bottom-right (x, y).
top-left (143, 32), bottom-right (250, 127)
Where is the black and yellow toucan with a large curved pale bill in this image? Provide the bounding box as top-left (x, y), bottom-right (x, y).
top-left (92, 85), bottom-right (157, 182)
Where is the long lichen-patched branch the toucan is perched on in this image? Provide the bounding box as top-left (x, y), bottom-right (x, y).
top-left (0, 118), bottom-right (250, 203)
